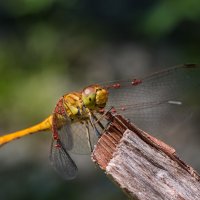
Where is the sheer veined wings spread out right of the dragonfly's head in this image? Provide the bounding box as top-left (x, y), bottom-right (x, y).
top-left (105, 65), bottom-right (200, 138)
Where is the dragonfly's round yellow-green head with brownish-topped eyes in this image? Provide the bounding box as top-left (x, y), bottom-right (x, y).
top-left (82, 85), bottom-right (108, 110)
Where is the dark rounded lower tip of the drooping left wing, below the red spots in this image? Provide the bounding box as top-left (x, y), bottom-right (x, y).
top-left (50, 140), bottom-right (78, 180)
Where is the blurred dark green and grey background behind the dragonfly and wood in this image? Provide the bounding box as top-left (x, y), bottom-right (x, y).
top-left (0, 0), bottom-right (200, 200)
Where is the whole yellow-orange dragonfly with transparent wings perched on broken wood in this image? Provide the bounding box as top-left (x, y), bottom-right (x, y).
top-left (0, 64), bottom-right (200, 180)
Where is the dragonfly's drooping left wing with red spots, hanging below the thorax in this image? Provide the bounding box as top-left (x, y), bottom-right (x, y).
top-left (50, 98), bottom-right (78, 180)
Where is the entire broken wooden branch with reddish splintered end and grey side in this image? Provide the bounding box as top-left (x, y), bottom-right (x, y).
top-left (92, 115), bottom-right (200, 200)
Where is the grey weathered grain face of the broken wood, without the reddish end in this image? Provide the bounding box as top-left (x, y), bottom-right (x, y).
top-left (106, 130), bottom-right (200, 200)
